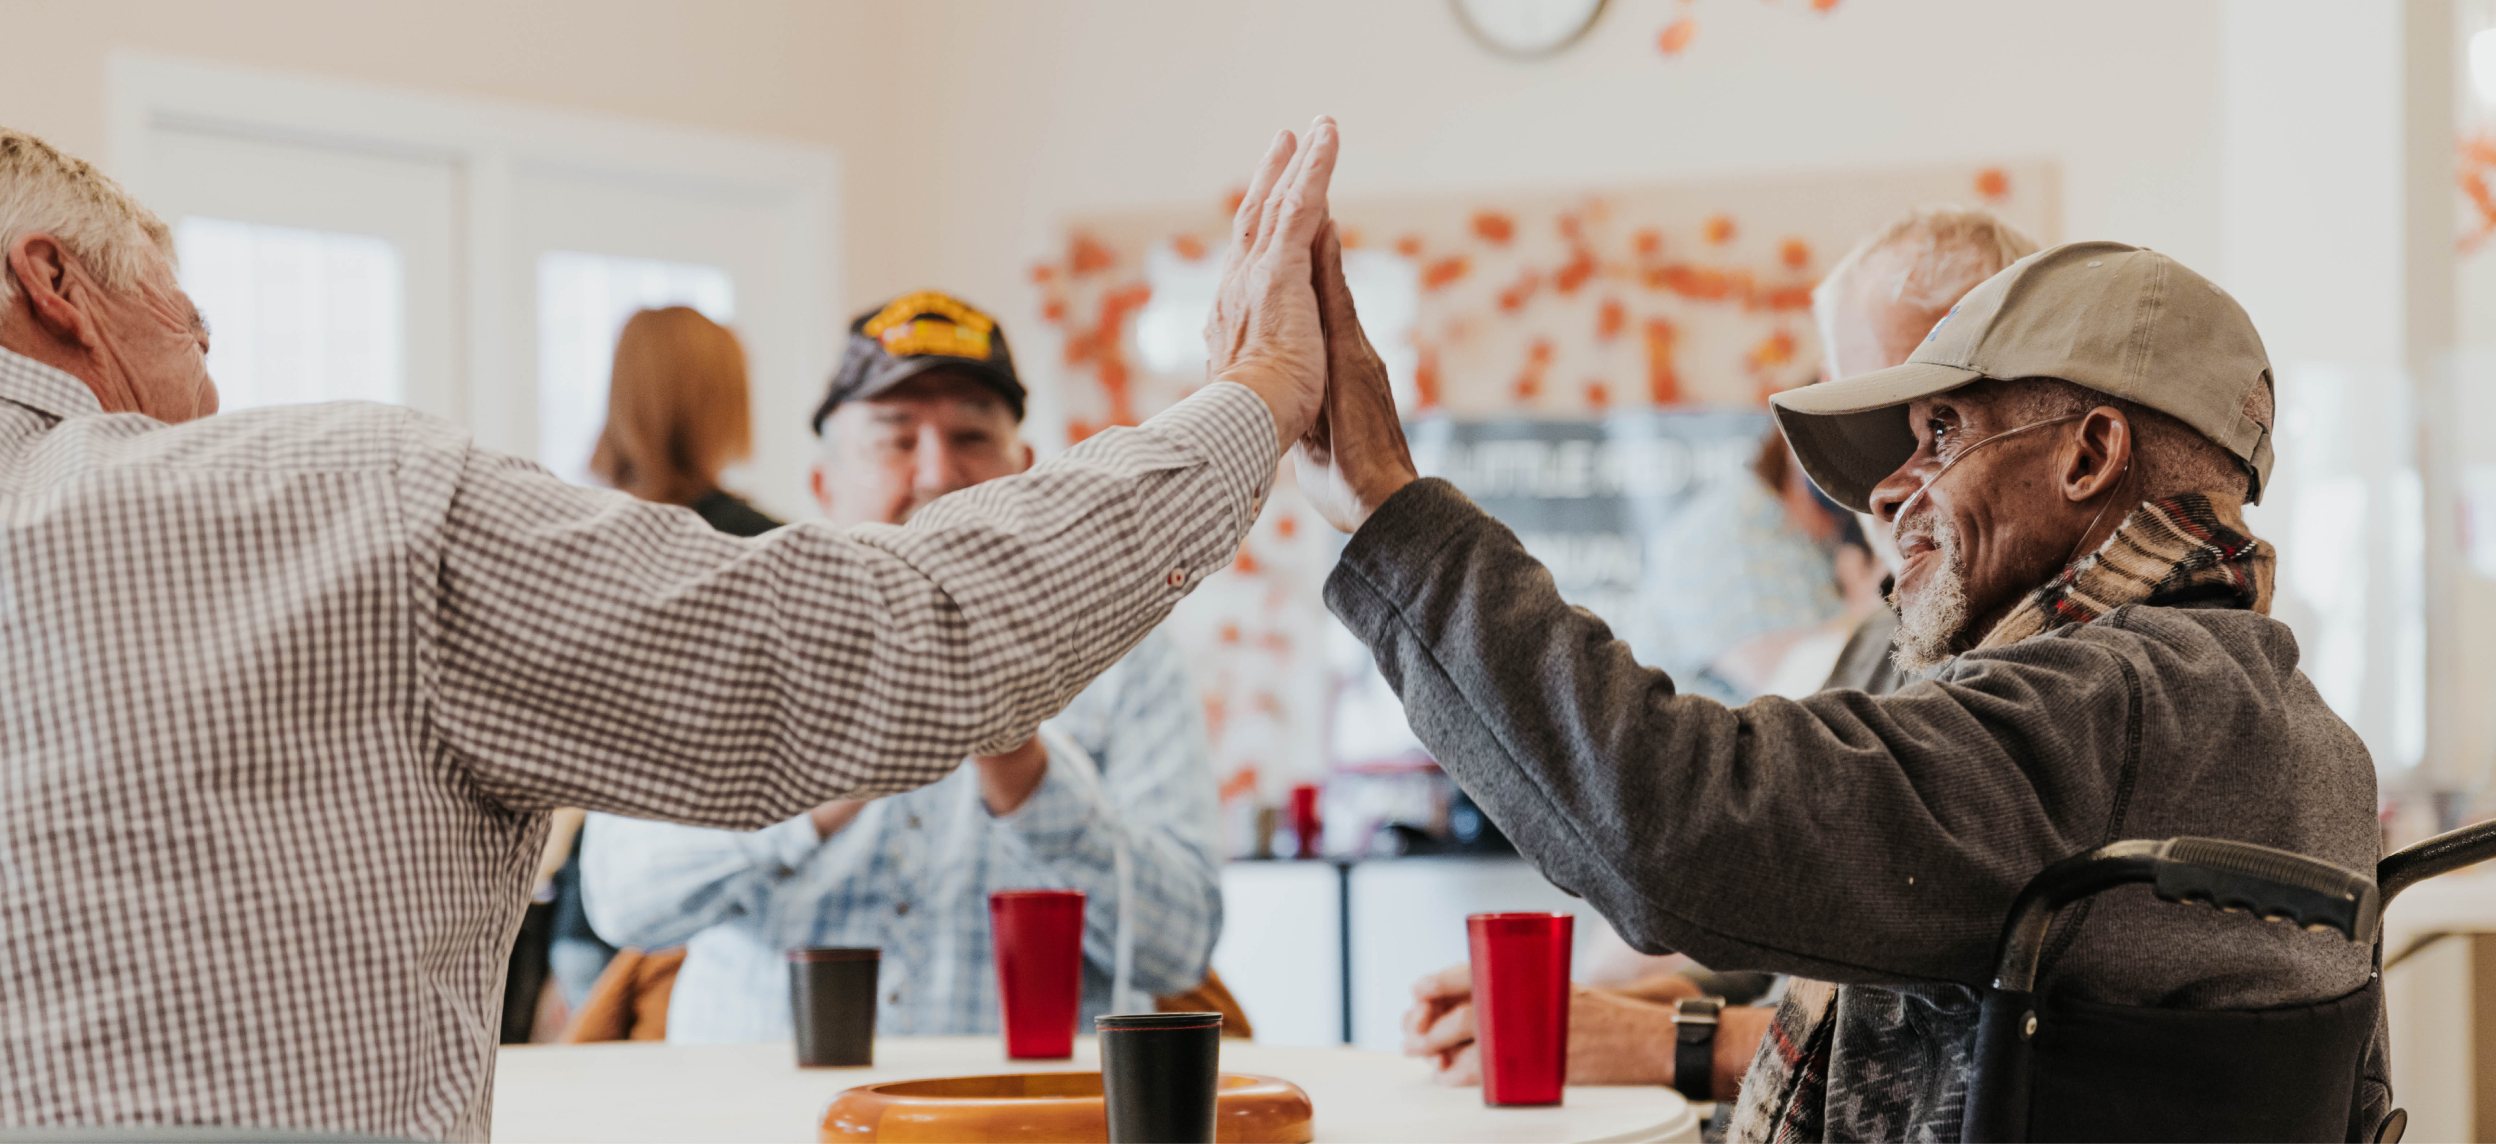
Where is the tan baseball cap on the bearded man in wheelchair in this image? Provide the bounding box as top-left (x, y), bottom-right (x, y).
top-left (1770, 242), bottom-right (2271, 512)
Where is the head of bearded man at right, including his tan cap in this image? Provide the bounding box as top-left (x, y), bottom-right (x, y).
top-left (1772, 242), bottom-right (2271, 669)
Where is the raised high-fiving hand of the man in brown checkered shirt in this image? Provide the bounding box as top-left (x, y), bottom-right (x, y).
top-left (1206, 115), bottom-right (1335, 457)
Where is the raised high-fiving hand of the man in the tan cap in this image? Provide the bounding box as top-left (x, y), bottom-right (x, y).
top-left (1293, 220), bottom-right (1420, 532)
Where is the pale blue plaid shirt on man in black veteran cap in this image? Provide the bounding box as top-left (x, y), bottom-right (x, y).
top-left (582, 632), bottom-right (1223, 1044)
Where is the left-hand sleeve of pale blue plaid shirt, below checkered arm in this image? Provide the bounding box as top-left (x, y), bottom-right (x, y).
top-left (582, 814), bottom-right (819, 949)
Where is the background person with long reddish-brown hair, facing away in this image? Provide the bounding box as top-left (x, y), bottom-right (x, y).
top-left (531, 305), bottom-right (781, 1012)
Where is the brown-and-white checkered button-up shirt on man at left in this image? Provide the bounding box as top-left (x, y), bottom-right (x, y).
top-left (0, 352), bottom-right (1273, 1139)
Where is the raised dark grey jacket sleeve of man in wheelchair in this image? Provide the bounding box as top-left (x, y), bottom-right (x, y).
top-left (1325, 480), bottom-right (2139, 982)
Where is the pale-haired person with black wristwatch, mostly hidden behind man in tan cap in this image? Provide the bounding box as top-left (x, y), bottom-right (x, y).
top-left (1405, 207), bottom-right (2037, 1109)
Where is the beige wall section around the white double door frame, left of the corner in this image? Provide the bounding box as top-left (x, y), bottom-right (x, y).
top-left (0, 0), bottom-right (911, 308)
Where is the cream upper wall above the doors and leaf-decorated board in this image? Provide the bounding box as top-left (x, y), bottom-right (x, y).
top-left (0, 0), bottom-right (2221, 437)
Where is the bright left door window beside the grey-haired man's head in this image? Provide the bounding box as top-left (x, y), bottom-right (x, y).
top-left (175, 215), bottom-right (407, 410)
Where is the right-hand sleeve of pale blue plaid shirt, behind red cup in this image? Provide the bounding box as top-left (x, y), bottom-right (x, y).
top-left (993, 634), bottom-right (1223, 994)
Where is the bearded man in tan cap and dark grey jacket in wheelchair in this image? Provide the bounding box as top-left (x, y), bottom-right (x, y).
top-left (1300, 242), bottom-right (2389, 1139)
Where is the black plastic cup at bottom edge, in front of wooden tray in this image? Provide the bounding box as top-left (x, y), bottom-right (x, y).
top-left (1093, 1014), bottom-right (1223, 1144)
